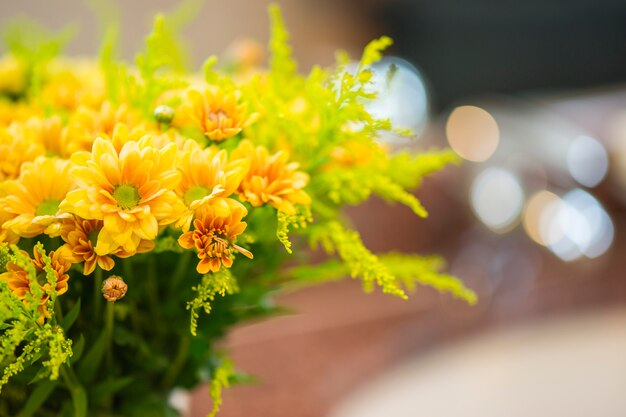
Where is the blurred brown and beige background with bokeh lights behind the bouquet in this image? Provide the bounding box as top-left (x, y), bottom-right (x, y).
top-left (0, 0), bottom-right (626, 417)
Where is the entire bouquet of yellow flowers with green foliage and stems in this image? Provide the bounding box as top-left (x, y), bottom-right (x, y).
top-left (0, 6), bottom-right (475, 417)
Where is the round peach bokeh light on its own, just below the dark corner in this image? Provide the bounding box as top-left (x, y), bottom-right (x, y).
top-left (446, 106), bottom-right (500, 162)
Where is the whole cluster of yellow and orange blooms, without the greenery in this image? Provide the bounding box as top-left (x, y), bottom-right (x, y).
top-left (0, 59), bottom-right (310, 316)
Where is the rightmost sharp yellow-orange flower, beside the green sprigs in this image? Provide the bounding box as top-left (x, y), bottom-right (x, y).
top-left (232, 140), bottom-right (311, 214)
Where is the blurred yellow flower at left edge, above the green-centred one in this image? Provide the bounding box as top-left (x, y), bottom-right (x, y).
top-left (0, 123), bottom-right (46, 180)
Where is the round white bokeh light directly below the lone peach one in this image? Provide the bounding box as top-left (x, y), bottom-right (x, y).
top-left (470, 167), bottom-right (524, 232)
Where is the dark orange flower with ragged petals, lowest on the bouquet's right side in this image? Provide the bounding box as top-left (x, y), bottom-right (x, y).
top-left (178, 199), bottom-right (252, 274)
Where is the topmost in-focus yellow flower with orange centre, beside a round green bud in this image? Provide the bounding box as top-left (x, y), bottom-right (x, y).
top-left (183, 88), bottom-right (258, 141)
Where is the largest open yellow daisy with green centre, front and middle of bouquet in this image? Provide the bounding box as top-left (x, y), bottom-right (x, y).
top-left (61, 136), bottom-right (185, 256)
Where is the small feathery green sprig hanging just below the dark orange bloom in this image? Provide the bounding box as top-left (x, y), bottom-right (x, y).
top-left (187, 268), bottom-right (239, 336)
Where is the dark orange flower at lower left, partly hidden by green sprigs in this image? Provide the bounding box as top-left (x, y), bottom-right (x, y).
top-left (0, 246), bottom-right (72, 323)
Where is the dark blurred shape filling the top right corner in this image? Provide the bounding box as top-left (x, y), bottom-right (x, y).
top-left (358, 0), bottom-right (626, 108)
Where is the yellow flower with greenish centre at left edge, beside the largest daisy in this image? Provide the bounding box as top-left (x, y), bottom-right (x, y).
top-left (0, 157), bottom-right (74, 237)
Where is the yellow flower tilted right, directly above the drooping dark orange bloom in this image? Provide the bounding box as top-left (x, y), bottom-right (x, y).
top-left (176, 140), bottom-right (249, 232)
